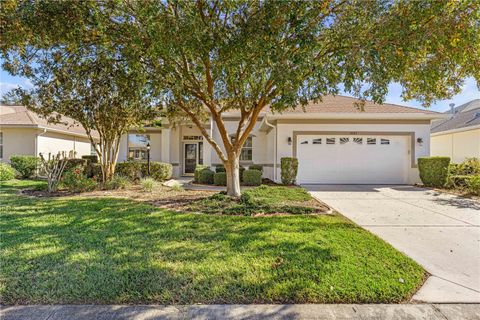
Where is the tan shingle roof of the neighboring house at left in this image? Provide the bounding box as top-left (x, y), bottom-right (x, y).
top-left (0, 105), bottom-right (98, 137)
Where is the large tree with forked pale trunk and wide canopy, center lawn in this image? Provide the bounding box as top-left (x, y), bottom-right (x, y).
top-left (0, 0), bottom-right (480, 196)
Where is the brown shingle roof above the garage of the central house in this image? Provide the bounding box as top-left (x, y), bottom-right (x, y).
top-left (267, 95), bottom-right (438, 115)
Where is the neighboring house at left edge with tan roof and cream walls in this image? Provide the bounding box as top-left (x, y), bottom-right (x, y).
top-left (0, 105), bottom-right (97, 162)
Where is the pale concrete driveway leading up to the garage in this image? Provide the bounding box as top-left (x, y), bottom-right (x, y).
top-left (303, 185), bottom-right (480, 303)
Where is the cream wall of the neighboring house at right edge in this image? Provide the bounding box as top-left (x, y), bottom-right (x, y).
top-left (431, 129), bottom-right (480, 163)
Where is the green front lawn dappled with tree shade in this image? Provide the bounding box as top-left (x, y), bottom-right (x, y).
top-left (0, 181), bottom-right (425, 304)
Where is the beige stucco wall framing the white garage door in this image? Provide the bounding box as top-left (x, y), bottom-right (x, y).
top-left (275, 123), bottom-right (430, 183)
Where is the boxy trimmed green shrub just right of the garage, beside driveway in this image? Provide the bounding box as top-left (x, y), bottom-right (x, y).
top-left (418, 157), bottom-right (450, 188)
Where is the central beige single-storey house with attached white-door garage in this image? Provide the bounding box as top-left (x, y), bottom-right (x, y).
top-left (118, 96), bottom-right (445, 184)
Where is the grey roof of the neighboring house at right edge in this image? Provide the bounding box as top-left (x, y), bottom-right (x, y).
top-left (432, 99), bottom-right (480, 133)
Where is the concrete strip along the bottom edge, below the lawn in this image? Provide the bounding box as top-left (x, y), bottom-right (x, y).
top-left (0, 304), bottom-right (480, 320)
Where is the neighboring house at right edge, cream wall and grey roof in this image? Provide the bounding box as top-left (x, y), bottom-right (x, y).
top-left (430, 99), bottom-right (480, 163)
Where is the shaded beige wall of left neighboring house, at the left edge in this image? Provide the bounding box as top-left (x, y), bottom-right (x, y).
top-left (0, 128), bottom-right (37, 162)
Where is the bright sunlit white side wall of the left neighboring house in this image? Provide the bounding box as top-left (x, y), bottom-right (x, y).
top-left (37, 132), bottom-right (91, 158)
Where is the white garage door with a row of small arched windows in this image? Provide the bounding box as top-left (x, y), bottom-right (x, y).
top-left (297, 135), bottom-right (410, 184)
